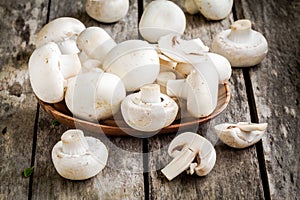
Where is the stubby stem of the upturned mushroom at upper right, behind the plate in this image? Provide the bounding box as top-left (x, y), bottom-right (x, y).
top-left (228, 19), bottom-right (252, 43)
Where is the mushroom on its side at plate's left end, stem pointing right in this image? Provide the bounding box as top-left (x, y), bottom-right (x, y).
top-left (28, 42), bottom-right (81, 103)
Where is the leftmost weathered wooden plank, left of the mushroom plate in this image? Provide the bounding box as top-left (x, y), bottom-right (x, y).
top-left (0, 0), bottom-right (47, 199)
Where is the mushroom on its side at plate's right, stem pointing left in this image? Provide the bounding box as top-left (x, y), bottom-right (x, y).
top-left (167, 56), bottom-right (219, 118)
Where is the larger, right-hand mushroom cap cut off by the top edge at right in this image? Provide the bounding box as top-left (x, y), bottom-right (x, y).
top-left (194, 0), bottom-right (233, 20)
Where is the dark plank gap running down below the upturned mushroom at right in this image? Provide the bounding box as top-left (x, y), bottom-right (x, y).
top-left (243, 69), bottom-right (271, 200)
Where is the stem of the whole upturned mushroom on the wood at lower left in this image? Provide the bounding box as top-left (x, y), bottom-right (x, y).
top-left (61, 130), bottom-right (89, 155)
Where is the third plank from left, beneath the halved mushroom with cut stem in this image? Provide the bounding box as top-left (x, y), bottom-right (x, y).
top-left (145, 1), bottom-right (263, 199)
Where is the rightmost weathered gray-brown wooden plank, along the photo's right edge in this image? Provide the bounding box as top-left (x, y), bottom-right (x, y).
top-left (236, 0), bottom-right (300, 199)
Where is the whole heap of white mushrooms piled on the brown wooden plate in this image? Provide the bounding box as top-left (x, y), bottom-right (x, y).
top-left (29, 12), bottom-right (231, 132)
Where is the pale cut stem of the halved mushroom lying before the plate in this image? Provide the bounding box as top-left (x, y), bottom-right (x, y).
top-left (161, 148), bottom-right (197, 181)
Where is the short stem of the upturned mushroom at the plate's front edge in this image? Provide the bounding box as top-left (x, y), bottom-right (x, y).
top-left (141, 84), bottom-right (161, 103)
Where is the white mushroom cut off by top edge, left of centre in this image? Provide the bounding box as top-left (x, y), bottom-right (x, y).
top-left (85, 0), bottom-right (129, 23)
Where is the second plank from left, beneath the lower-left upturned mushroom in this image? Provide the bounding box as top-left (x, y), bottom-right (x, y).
top-left (32, 0), bottom-right (144, 199)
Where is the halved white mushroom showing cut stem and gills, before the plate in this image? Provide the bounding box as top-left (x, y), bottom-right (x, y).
top-left (161, 132), bottom-right (216, 181)
